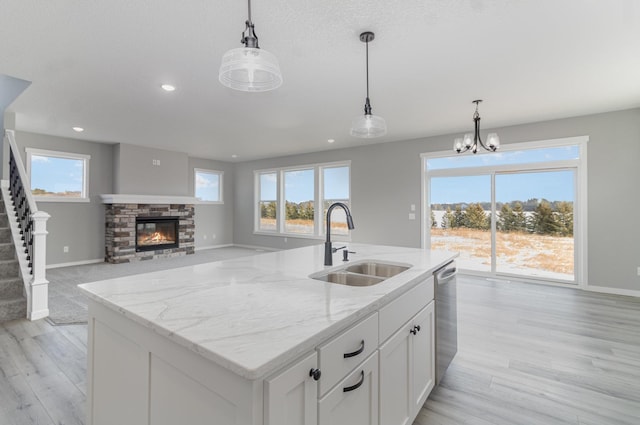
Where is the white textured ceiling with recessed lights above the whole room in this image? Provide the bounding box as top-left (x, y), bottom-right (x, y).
top-left (0, 0), bottom-right (640, 161)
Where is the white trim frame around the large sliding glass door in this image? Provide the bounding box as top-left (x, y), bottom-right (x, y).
top-left (420, 136), bottom-right (589, 289)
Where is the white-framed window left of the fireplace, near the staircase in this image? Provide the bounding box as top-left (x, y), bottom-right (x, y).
top-left (26, 148), bottom-right (91, 202)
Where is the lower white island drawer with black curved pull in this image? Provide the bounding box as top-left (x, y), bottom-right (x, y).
top-left (318, 352), bottom-right (378, 425)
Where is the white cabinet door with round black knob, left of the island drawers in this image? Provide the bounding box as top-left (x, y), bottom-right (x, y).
top-left (265, 352), bottom-right (318, 425)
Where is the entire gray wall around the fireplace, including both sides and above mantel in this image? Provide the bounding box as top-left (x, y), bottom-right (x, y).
top-left (11, 132), bottom-right (234, 265)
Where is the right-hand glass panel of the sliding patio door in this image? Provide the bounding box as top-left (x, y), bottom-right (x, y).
top-left (495, 170), bottom-right (575, 281)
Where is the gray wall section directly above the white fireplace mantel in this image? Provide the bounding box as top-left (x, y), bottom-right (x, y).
top-left (113, 143), bottom-right (189, 196)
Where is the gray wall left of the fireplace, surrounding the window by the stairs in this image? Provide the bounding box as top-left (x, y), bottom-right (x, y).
top-left (16, 132), bottom-right (113, 264)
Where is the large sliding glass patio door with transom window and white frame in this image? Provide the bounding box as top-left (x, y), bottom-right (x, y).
top-left (423, 137), bottom-right (588, 284)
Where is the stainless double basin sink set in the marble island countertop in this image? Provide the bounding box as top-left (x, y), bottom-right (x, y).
top-left (309, 260), bottom-right (411, 286)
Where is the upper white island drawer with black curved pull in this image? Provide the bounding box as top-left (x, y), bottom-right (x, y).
top-left (318, 313), bottom-right (378, 397)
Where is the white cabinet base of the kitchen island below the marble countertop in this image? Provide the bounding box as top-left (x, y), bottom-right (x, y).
top-left (88, 272), bottom-right (435, 425)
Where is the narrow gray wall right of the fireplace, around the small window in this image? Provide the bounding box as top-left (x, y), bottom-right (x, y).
top-left (189, 158), bottom-right (234, 249)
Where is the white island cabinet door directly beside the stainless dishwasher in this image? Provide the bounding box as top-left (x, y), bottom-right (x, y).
top-left (411, 301), bottom-right (435, 417)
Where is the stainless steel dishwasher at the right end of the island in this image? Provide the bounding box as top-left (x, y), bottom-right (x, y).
top-left (433, 261), bottom-right (458, 385)
